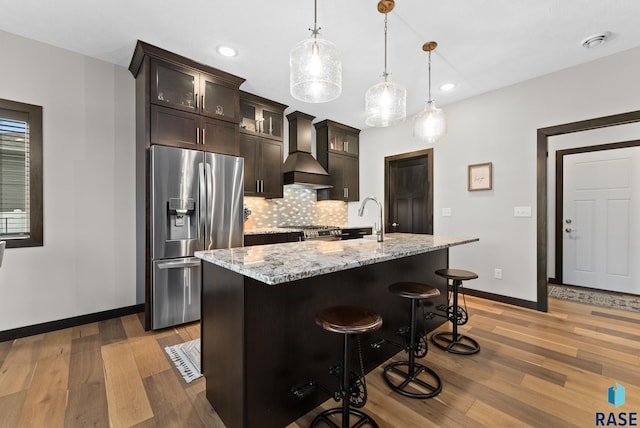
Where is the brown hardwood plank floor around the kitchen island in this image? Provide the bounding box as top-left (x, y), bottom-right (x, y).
top-left (0, 297), bottom-right (640, 428)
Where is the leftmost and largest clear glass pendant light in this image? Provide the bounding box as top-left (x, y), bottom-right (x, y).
top-left (289, 0), bottom-right (342, 103)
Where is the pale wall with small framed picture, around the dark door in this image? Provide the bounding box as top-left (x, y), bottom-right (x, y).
top-left (356, 48), bottom-right (640, 301)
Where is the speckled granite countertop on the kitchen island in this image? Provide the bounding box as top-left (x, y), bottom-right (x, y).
top-left (195, 233), bottom-right (478, 285)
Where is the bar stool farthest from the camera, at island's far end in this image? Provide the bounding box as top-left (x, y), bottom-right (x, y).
top-left (431, 269), bottom-right (480, 355)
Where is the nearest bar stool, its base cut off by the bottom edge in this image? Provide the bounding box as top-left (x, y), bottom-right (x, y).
top-left (311, 306), bottom-right (382, 428)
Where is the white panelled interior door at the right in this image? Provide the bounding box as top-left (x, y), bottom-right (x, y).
top-left (562, 147), bottom-right (640, 294)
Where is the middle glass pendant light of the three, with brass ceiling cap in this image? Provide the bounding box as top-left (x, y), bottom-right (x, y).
top-left (365, 0), bottom-right (407, 127)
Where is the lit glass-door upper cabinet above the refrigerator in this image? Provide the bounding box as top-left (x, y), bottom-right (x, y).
top-left (151, 59), bottom-right (239, 123)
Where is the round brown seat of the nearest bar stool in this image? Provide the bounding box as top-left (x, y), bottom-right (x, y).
top-left (316, 306), bottom-right (382, 334)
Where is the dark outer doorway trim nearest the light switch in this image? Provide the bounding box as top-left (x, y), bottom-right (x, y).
top-left (536, 110), bottom-right (640, 312)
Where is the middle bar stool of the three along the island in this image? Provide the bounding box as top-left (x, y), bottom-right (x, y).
top-left (384, 282), bottom-right (442, 398)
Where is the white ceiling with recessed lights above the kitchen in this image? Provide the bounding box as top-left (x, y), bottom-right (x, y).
top-left (0, 0), bottom-right (640, 129)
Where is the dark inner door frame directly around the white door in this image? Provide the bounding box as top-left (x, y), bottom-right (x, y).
top-left (549, 140), bottom-right (640, 284)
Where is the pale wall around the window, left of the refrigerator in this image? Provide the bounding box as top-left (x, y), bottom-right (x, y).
top-left (0, 32), bottom-right (135, 331)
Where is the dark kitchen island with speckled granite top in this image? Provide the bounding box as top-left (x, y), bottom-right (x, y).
top-left (196, 233), bottom-right (478, 428)
